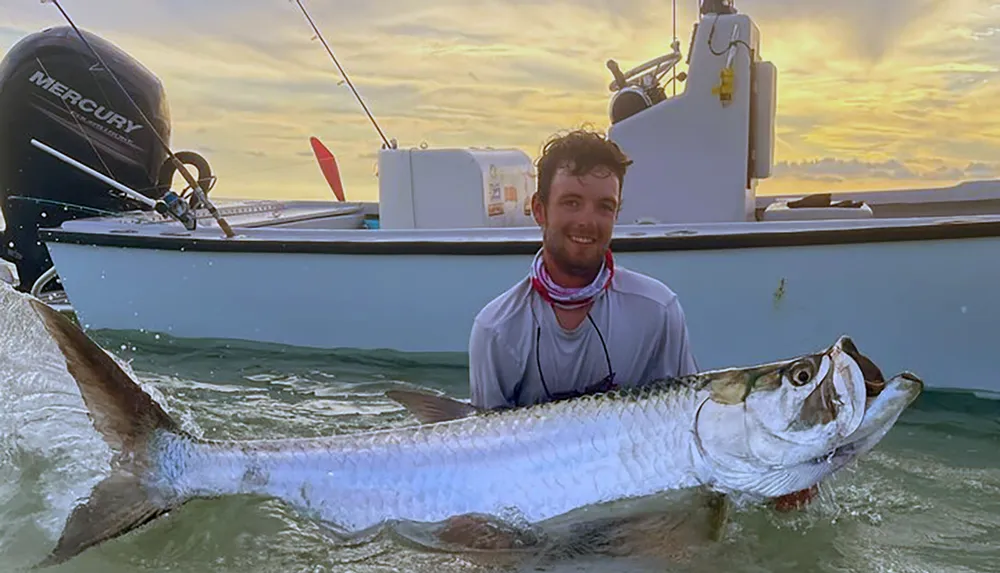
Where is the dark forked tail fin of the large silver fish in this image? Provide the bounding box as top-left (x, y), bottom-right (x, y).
top-left (29, 299), bottom-right (190, 566)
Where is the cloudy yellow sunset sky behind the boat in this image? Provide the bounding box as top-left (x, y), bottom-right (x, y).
top-left (0, 0), bottom-right (1000, 200)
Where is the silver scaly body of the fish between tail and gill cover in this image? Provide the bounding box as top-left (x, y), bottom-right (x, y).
top-left (166, 386), bottom-right (707, 530)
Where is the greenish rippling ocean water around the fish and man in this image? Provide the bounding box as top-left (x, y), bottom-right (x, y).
top-left (0, 290), bottom-right (1000, 573)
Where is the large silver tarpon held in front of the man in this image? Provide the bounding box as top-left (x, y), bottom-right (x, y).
top-left (17, 292), bottom-right (923, 564)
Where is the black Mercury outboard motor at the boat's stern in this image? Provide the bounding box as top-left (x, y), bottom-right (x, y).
top-left (0, 27), bottom-right (170, 290)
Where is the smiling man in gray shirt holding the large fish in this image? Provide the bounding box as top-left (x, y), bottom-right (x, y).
top-left (469, 130), bottom-right (697, 408)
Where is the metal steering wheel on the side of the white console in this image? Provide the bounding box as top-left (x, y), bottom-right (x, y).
top-left (607, 40), bottom-right (687, 124)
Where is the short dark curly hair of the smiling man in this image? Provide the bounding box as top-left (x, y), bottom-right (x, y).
top-left (536, 129), bottom-right (632, 205)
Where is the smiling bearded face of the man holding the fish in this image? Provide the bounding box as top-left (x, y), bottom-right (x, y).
top-left (532, 167), bottom-right (619, 281)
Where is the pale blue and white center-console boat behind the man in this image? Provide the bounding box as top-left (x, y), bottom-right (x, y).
top-left (0, 2), bottom-right (1000, 394)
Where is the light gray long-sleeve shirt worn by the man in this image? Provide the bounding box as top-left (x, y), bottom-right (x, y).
top-left (469, 266), bottom-right (697, 408)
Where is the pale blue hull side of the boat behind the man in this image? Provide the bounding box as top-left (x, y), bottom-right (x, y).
top-left (41, 213), bottom-right (1000, 392)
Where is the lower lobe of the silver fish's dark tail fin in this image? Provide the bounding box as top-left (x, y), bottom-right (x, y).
top-left (36, 471), bottom-right (178, 567)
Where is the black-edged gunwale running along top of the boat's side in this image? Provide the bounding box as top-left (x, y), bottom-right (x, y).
top-left (39, 216), bottom-right (1000, 255)
